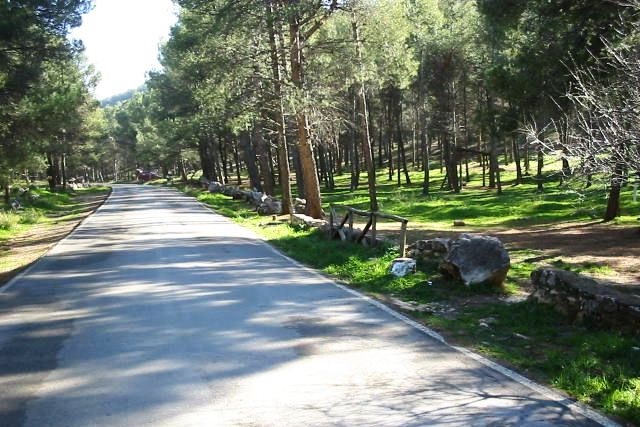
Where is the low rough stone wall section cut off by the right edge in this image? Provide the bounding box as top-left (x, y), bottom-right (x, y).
top-left (530, 268), bottom-right (640, 334)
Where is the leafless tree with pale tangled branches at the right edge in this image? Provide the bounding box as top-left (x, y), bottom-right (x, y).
top-left (527, 4), bottom-right (640, 221)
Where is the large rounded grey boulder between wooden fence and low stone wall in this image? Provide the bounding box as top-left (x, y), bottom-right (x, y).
top-left (439, 234), bottom-right (511, 286)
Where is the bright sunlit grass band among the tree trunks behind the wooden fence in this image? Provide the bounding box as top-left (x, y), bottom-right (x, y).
top-left (323, 169), bottom-right (640, 229)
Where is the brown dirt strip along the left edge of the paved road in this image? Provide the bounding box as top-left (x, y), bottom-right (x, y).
top-left (0, 194), bottom-right (108, 286)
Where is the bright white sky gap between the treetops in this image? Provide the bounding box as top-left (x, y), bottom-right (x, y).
top-left (71, 0), bottom-right (177, 99)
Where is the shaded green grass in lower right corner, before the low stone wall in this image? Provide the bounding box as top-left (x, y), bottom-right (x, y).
top-left (422, 302), bottom-right (640, 423)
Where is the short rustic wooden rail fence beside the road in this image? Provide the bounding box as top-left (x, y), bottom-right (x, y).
top-left (329, 205), bottom-right (409, 258)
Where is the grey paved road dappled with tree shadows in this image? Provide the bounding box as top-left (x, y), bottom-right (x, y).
top-left (0, 186), bottom-right (616, 427)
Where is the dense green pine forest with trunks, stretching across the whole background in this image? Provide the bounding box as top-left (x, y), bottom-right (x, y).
top-left (0, 0), bottom-right (640, 219)
